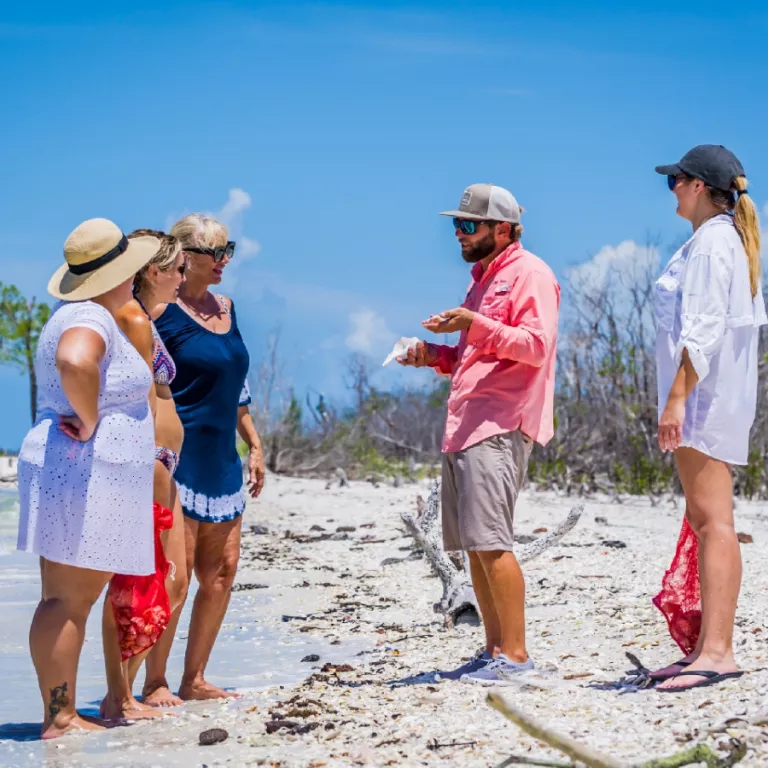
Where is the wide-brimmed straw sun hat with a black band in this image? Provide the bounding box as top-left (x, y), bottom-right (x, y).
top-left (48, 219), bottom-right (160, 301)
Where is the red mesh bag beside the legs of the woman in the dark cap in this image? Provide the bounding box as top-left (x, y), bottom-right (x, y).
top-left (653, 517), bottom-right (701, 656)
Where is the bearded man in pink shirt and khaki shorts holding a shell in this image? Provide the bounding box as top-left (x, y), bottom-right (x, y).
top-left (400, 184), bottom-right (560, 685)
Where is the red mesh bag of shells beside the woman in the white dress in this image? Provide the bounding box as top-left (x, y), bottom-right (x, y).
top-left (107, 502), bottom-right (173, 661)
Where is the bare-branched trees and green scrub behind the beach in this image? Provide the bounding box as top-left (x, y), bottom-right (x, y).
top-left (6, 242), bottom-right (768, 503)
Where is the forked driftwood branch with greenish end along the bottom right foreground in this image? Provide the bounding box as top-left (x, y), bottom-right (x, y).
top-left (485, 693), bottom-right (747, 768)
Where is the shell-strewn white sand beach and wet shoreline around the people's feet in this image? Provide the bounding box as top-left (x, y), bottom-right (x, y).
top-left (0, 477), bottom-right (768, 767)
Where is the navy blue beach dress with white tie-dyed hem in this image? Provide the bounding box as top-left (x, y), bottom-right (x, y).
top-left (155, 297), bottom-right (251, 523)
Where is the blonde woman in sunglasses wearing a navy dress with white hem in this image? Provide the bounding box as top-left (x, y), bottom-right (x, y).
top-left (155, 214), bottom-right (264, 700)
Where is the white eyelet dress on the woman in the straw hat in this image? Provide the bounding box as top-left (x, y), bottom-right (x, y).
top-left (18, 301), bottom-right (155, 576)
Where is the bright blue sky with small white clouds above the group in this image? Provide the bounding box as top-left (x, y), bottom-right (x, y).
top-left (0, 0), bottom-right (768, 448)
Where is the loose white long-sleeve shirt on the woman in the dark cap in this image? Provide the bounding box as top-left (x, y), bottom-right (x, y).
top-left (654, 214), bottom-right (768, 464)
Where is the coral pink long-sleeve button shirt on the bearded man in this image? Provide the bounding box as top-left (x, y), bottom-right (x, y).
top-left (433, 242), bottom-right (560, 453)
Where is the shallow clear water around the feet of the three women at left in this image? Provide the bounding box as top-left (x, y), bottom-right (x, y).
top-left (0, 491), bottom-right (358, 766)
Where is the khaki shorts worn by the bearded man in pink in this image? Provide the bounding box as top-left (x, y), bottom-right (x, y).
top-left (441, 430), bottom-right (533, 552)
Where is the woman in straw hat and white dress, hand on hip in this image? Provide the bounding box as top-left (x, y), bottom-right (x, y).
top-left (18, 219), bottom-right (160, 739)
